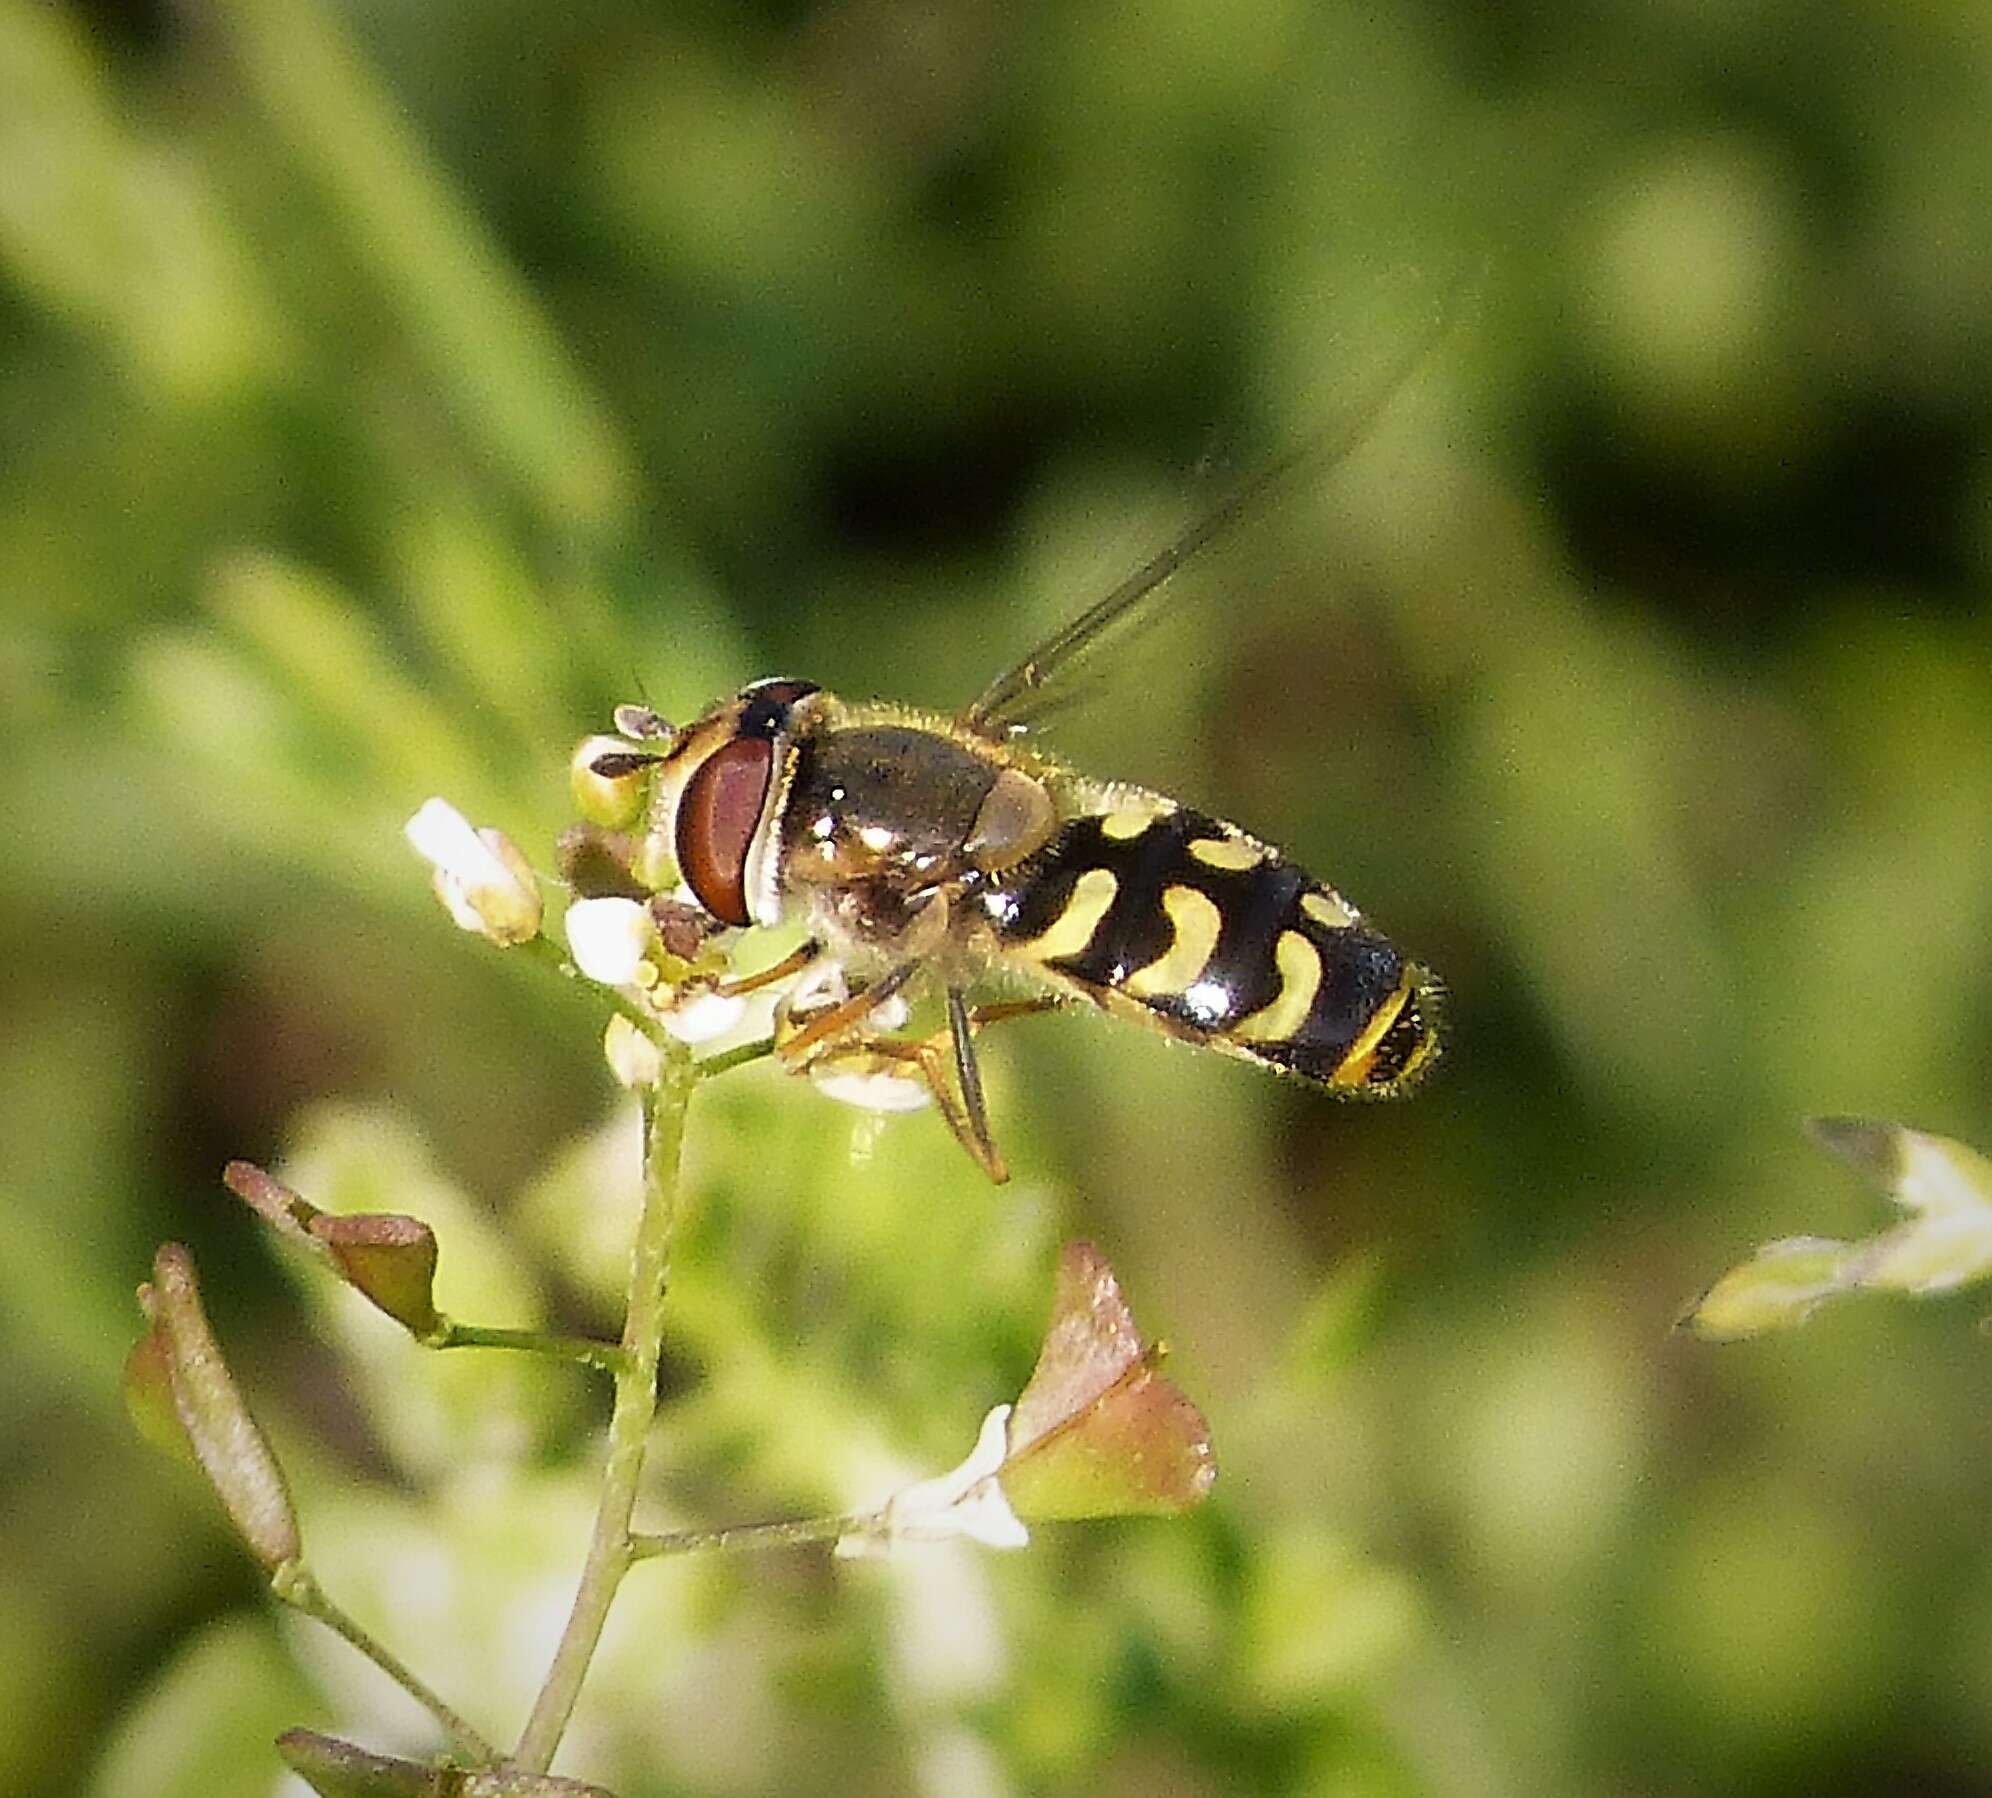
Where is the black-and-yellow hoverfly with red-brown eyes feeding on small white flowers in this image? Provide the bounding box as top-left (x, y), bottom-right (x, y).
top-left (594, 410), bottom-right (1442, 1181)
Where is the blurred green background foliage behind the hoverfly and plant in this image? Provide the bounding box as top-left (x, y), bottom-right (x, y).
top-left (0, 0), bottom-right (1992, 1798)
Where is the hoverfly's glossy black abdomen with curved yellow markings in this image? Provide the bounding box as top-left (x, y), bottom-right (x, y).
top-left (984, 794), bottom-right (1438, 1095)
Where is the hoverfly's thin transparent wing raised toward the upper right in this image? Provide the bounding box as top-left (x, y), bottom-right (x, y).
top-left (960, 295), bottom-right (1454, 739)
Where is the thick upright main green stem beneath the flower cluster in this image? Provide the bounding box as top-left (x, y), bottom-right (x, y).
top-left (514, 1041), bottom-right (699, 1772)
